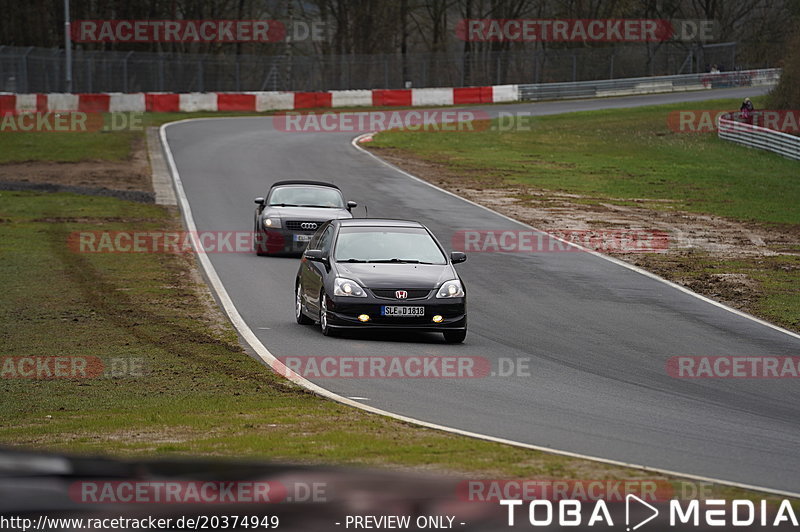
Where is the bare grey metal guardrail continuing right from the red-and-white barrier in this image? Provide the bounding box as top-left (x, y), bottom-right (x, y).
top-left (519, 68), bottom-right (781, 100)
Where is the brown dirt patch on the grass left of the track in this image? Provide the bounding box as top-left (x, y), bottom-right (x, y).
top-left (0, 138), bottom-right (153, 193)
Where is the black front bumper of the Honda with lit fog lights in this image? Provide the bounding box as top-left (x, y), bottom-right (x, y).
top-left (328, 290), bottom-right (467, 332)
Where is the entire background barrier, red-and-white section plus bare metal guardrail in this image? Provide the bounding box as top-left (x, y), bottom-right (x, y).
top-left (0, 68), bottom-right (781, 114)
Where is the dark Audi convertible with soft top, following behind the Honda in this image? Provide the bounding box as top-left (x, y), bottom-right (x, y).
top-left (253, 181), bottom-right (358, 255)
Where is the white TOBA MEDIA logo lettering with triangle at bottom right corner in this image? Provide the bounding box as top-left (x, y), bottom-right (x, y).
top-left (499, 493), bottom-right (798, 531)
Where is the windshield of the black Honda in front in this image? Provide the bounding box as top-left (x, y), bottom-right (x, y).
top-left (334, 227), bottom-right (447, 264)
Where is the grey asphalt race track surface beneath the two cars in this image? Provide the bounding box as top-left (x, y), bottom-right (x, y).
top-left (165, 89), bottom-right (800, 493)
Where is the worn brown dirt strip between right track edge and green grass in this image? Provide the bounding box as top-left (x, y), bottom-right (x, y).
top-left (370, 147), bottom-right (800, 329)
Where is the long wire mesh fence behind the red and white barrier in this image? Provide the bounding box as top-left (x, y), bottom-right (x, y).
top-left (0, 43), bottom-right (744, 93)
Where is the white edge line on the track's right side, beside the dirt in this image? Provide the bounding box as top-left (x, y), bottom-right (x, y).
top-left (350, 132), bottom-right (800, 339)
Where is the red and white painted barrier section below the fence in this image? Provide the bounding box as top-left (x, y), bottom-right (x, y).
top-left (0, 85), bottom-right (519, 115)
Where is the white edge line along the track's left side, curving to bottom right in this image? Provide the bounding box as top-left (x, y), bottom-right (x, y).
top-left (159, 117), bottom-right (800, 498)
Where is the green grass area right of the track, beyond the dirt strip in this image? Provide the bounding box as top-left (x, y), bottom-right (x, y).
top-left (370, 96), bottom-right (800, 224)
